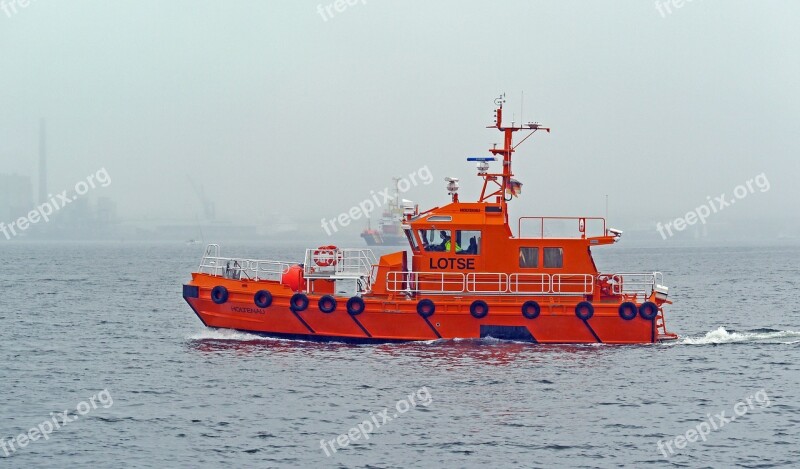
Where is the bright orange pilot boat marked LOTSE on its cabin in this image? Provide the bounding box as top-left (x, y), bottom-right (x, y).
top-left (183, 98), bottom-right (677, 344)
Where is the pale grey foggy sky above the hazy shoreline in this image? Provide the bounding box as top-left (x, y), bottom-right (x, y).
top-left (0, 0), bottom-right (800, 245)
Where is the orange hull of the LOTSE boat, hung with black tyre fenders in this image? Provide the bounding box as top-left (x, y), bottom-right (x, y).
top-left (183, 274), bottom-right (675, 344)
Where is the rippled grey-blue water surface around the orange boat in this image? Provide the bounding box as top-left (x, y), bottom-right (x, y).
top-left (0, 243), bottom-right (800, 468)
